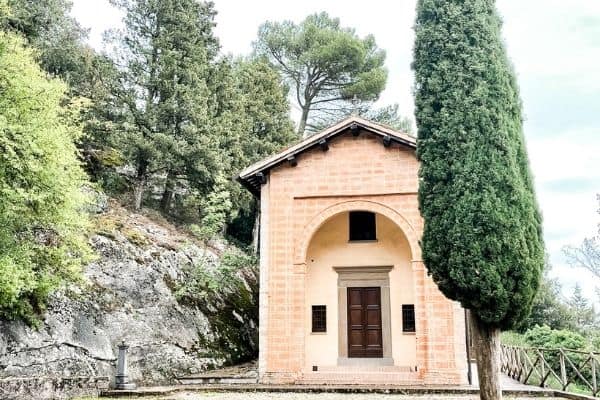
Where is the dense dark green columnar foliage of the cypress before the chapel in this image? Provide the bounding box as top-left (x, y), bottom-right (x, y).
top-left (413, 0), bottom-right (544, 329)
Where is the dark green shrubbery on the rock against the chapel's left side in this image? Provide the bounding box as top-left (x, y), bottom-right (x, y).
top-left (176, 249), bottom-right (258, 363)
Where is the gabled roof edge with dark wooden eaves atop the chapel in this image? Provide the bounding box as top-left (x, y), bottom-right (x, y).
top-left (238, 116), bottom-right (417, 195)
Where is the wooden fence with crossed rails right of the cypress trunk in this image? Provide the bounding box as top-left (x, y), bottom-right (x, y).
top-left (501, 345), bottom-right (600, 397)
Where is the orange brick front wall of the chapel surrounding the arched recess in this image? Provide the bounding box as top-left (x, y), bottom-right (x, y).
top-left (241, 119), bottom-right (466, 384)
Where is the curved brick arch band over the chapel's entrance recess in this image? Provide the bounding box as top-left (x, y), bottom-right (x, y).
top-left (294, 200), bottom-right (421, 264)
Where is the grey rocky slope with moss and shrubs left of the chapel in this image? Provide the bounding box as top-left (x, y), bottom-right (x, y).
top-left (0, 203), bottom-right (257, 384)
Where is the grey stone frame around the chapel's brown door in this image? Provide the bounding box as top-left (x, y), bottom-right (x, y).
top-left (333, 265), bottom-right (394, 365)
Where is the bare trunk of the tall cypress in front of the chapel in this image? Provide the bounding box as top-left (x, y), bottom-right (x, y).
top-left (469, 312), bottom-right (502, 400)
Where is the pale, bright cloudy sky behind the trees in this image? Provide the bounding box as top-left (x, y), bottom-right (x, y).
top-left (72, 0), bottom-right (600, 303)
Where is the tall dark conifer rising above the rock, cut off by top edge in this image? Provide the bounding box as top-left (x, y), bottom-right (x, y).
top-left (107, 0), bottom-right (221, 210)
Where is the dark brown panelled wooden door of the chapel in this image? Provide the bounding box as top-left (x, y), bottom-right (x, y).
top-left (348, 287), bottom-right (383, 358)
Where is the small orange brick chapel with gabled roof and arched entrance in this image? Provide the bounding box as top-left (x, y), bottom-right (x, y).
top-left (238, 116), bottom-right (467, 385)
